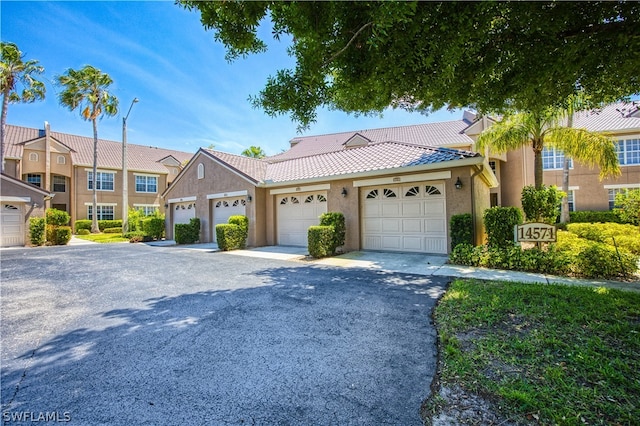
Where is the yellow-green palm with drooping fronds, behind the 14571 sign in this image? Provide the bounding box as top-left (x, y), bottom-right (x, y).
top-left (476, 108), bottom-right (620, 188)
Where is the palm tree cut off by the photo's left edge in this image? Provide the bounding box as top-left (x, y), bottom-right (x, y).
top-left (0, 42), bottom-right (46, 173)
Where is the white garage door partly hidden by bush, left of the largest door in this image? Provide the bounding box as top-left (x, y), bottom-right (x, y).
top-left (276, 192), bottom-right (327, 247)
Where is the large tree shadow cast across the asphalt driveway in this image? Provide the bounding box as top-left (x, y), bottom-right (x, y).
top-left (2, 258), bottom-right (446, 425)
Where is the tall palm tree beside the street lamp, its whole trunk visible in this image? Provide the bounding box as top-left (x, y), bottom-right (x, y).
top-left (58, 65), bottom-right (118, 233)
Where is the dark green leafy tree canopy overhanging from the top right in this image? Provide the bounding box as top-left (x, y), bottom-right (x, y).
top-left (179, 0), bottom-right (640, 127)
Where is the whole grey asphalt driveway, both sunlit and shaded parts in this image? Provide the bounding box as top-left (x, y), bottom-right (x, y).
top-left (1, 244), bottom-right (447, 425)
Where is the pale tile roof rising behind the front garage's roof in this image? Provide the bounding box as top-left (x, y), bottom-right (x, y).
top-left (269, 115), bottom-right (473, 161)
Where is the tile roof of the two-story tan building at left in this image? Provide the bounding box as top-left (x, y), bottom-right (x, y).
top-left (5, 125), bottom-right (193, 174)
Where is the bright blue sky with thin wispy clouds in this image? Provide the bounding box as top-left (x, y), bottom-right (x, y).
top-left (0, 0), bottom-right (462, 155)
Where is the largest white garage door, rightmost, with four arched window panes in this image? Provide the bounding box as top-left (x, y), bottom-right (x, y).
top-left (361, 182), bottom-right (447, 253)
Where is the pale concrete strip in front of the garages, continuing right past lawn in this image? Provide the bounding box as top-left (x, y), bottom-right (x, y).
top-left (146, 241), bottom-right (640, 292)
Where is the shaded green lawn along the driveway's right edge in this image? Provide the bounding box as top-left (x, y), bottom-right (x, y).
top-left (435, 280), bottom-right (640, 425)
